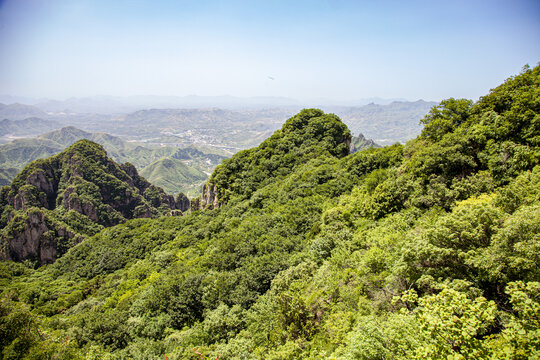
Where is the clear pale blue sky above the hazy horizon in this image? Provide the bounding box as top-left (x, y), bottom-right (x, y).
top-left (0, 0), bottom-right (540, 100)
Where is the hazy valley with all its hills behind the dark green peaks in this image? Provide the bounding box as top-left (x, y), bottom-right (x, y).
top-left (0, 97), bottom-right (435, 196)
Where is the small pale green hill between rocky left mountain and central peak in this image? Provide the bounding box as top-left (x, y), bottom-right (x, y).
top-left (141, 158), bottom-right (208, 195)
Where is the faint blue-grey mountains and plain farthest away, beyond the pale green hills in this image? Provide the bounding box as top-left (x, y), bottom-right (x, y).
top-left (0, 96), bottom-right (435, 149)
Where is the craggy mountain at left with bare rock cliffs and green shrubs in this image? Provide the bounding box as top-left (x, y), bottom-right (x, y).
top-left (0, 140), bottom-right (189, 265)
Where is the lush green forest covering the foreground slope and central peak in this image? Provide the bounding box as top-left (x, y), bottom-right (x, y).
top-left (0, 66), bottom-right (540, 360)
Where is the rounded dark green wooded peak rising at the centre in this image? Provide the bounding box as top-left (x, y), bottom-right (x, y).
top-left (209, 109), bottom-right (351, 202)
